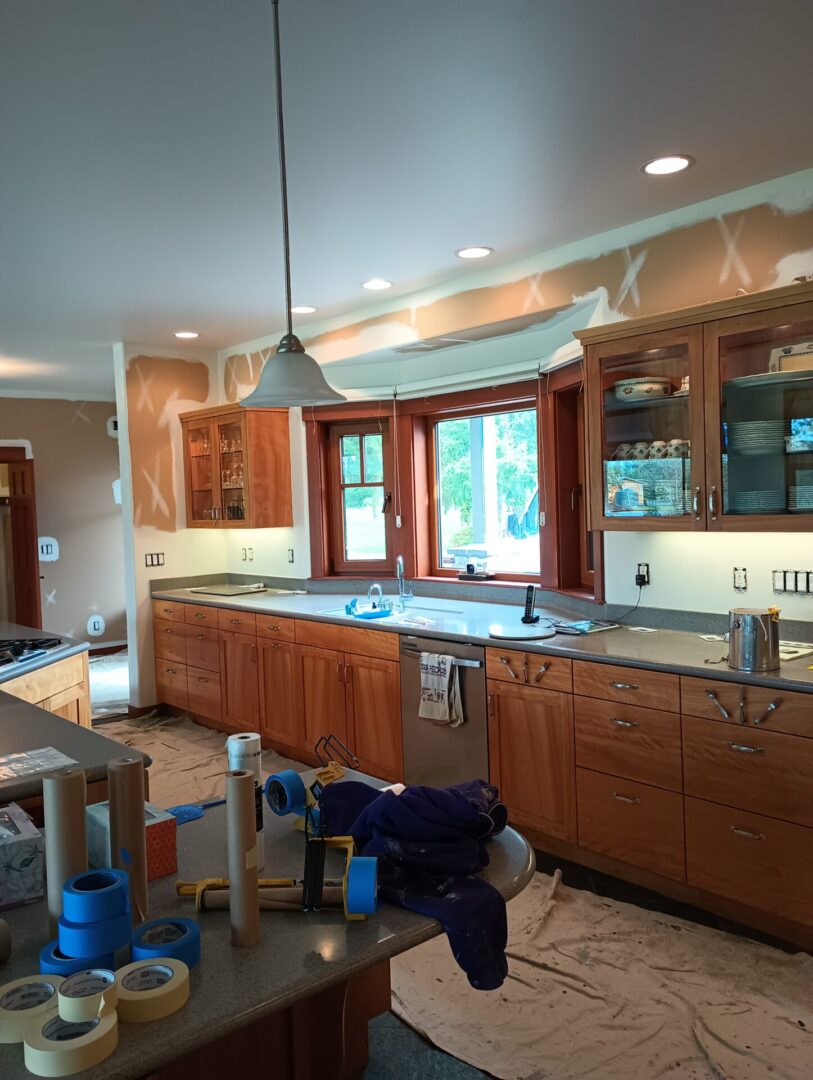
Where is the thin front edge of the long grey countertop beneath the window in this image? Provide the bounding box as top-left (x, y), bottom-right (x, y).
top-left (152, 592), bottom-right (813, 693)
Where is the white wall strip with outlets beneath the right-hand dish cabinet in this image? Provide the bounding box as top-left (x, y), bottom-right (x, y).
top-left (605, 532), bottom-right (813, 621)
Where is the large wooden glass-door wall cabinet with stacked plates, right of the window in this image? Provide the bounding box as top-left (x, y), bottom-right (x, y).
top-left (577, 284), bottom-right (813, 531)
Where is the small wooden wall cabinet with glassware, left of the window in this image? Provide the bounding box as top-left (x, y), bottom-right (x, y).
top-left (180, 405), bottom-right (294, 529)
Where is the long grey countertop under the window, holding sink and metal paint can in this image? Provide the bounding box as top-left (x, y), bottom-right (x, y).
top-left (153, 589), bottom-right (813, 693)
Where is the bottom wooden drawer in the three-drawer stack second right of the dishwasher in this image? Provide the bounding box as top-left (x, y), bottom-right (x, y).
top-left (575, 769), bottom-right (686, 881)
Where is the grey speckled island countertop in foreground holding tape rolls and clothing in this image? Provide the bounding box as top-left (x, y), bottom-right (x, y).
top-left (0, 782), bottom-right (533, 1080)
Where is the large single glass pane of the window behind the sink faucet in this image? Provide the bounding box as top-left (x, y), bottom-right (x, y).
top-left (435, 409), bottom-right (539, 573)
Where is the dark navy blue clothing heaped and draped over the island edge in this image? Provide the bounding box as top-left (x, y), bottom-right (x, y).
top-left (320, 780), bottom-right (507, 990)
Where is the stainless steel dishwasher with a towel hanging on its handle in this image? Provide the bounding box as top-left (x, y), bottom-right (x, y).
top-left (401, 635), bottom-right (488, 787)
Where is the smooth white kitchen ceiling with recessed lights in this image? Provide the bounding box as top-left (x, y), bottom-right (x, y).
top-left (0, 0), bottom-right (813, 395)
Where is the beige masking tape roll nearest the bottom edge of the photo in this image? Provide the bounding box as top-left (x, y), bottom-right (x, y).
top-left (24, 1009), bottom-right (119, 1077)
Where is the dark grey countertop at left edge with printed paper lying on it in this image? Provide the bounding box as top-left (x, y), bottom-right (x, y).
top-left (0, 690), bottom-right (152, 803)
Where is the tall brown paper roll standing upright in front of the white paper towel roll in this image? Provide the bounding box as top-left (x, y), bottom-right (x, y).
top-left (226, 769), bottom-right (260, 948)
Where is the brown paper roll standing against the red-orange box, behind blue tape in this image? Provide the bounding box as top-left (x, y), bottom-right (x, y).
top-left (107, 757), bottom-right (149, 922)
